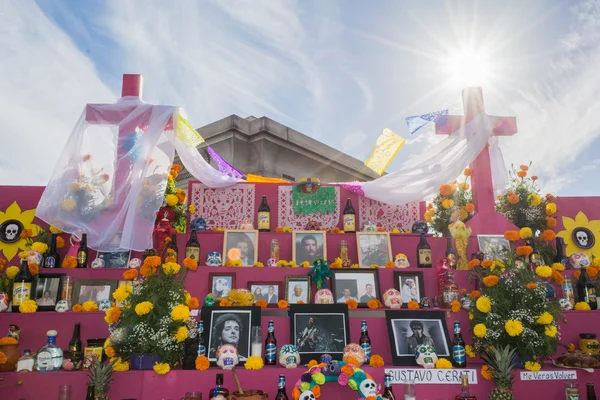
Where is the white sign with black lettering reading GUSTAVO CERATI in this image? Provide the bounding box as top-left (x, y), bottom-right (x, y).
top-left (385, 368), bottom-right (477, 385)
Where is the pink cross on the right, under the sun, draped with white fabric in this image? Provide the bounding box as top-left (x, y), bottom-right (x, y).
top-left (435, 87), bottom-right (517, 235)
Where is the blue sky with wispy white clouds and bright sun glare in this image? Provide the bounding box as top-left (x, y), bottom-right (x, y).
top-left (0, 0), bottom-right (600, 195)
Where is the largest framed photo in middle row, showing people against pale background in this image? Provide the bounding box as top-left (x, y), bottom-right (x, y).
top-left (331, 269), bottom-right (381, 307)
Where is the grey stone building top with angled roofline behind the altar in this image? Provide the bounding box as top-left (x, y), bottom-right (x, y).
top-left (175, 115), bottom-right (378, 190)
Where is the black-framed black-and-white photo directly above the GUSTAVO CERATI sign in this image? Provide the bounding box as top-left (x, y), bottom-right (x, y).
top-left (385, 310), bottom-right (451, 365)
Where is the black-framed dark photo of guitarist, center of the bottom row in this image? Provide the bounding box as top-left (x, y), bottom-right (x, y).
top-left (290, 304), bottom-right (350, 364)
